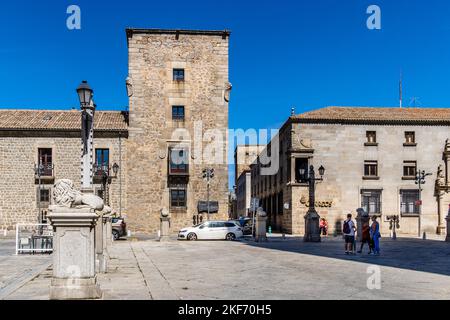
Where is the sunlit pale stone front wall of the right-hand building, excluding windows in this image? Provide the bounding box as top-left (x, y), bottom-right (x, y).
top-left (293, 124), bottom-right (450, 236)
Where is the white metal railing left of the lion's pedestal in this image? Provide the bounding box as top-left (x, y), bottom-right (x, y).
top-left (16, 223), bottom-right (53, 255)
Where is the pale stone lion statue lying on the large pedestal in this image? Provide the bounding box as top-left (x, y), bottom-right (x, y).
top-left (52, 179), bottom-right (111, 213)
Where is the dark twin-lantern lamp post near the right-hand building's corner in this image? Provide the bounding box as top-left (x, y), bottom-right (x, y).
top-left (300, 165), bottom-right (325, 242)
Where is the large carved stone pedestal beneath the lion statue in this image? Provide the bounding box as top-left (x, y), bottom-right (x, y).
top-left (47, 207), bottom-right (102, 300)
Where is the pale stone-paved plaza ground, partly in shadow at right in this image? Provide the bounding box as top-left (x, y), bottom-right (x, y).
top-left (2, 237), bottom-right (450, 300)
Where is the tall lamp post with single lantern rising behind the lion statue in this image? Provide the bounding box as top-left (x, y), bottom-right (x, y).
top-left (77, 81), bottom-right (95, 193)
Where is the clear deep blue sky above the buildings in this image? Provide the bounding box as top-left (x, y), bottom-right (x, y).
top-left (0, 0), bottom-right (450, 188)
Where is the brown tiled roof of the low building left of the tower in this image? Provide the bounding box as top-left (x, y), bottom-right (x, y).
top-left (0, 109), bottom-right (128, 131)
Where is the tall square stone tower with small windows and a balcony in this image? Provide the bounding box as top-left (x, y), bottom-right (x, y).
top-left (127, 29), bottom-right (231, 232)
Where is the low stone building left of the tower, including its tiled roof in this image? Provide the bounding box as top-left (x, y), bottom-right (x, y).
top-left (0, 110), bottom-right (128, 230)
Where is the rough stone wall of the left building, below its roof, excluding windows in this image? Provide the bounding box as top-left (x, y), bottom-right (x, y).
top-left (0, 131), bottom-right (127, 230)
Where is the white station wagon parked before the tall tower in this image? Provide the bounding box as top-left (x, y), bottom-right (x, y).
top-left (178, 221), bottom-right (244, 241)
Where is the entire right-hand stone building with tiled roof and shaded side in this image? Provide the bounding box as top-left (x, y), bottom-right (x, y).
top-left (252, 107), bottom-right (450, 236)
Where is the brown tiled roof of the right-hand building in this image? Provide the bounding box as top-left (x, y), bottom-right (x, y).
top-left (291, 107), bottom-right (450, 123)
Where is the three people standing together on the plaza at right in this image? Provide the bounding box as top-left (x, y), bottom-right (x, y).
top-left (343, 214), bottom-right (381, 255)
